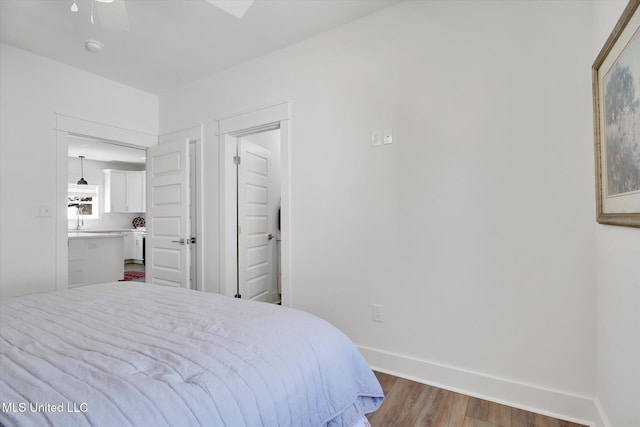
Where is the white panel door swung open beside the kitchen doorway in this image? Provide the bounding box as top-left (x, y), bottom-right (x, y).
top-left (145, 141), bottom-right (190, 288)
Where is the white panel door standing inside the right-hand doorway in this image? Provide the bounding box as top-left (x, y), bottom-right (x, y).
top-left (238, 139), bottom-right (275, 302)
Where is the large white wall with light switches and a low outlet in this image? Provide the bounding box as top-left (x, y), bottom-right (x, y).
top-left (160, 1), bottom-right (596, 419)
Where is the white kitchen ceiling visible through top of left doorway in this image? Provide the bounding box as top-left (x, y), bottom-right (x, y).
top-left (68, 135), bottom-right (146, 165)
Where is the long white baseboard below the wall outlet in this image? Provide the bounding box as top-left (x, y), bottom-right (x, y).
top-left (358, 346), bottom-right (596, 427)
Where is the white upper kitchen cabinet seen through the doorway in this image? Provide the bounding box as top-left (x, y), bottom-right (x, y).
top-left (103, 169), bottom-right (146, 212)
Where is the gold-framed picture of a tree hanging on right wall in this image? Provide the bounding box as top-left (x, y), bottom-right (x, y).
top-left (592, 0), bottom-right (640, 227)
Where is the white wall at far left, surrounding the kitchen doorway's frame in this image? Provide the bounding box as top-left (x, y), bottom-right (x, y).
top-left (0, 44), bottom-right (158, 297)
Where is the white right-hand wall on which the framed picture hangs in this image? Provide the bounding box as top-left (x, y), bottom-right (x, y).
top-left (593, 1), bottom-right (640, 427)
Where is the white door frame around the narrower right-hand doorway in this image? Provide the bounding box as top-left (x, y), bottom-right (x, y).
top-left (218, 101), bottom-right (293, 306)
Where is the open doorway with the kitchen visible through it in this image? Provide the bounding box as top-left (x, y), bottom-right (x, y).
top-left (67, 134), bottom-right (146, 287)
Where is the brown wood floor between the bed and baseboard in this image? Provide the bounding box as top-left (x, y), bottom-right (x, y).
top-left (368, 372), bottom-right (584, 427)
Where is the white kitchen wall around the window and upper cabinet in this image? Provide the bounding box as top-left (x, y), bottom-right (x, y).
top-left (67, 157), bottom-right (145, 230)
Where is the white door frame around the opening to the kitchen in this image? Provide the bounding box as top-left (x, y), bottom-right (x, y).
top-left (53, 113), bottom-right (158, 290)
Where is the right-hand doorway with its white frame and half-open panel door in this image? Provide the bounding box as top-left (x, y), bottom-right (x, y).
top-left (219, 103), bottom-right (291, 305)
